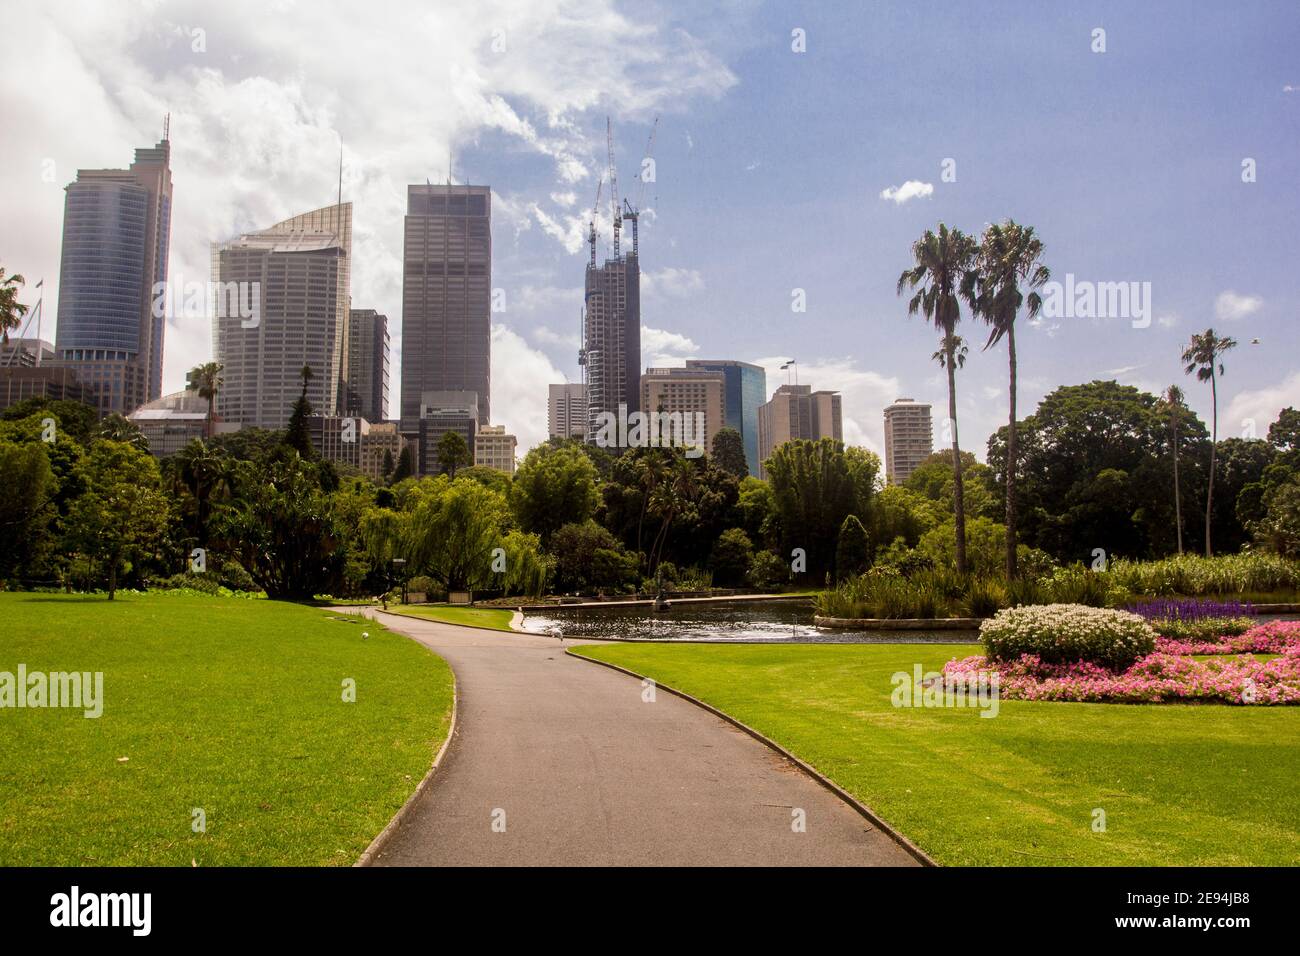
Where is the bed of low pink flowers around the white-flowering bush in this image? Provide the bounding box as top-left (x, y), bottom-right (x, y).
top-left (944, 644), bottom-right (1300, 704)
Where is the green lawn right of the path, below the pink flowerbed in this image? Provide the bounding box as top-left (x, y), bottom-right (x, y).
top-left (576, 644), bottom-right (1300, 865)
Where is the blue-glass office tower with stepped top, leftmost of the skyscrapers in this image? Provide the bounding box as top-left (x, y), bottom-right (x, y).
top-left (55, 133), bottom-right (172, 415)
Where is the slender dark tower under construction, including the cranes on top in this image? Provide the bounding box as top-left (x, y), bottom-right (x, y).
top-left (579, 121), bottom-right (658, 441)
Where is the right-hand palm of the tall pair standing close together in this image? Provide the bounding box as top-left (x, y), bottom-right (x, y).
top-left (962, 219), bottom-right (1052, 581)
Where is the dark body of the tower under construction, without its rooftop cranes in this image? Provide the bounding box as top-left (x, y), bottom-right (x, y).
top-left (579, 252), bottom-right (641, 441)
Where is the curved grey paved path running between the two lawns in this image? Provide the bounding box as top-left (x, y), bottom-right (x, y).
top-left (348, 611), bottom-right (917, 866)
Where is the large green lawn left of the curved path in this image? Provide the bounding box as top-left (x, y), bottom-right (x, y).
top-left (0, 593), bottom-right (452, 866)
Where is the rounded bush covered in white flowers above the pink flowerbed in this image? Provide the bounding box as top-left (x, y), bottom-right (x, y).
top-left (979, 604), bottom-right (1156, 671)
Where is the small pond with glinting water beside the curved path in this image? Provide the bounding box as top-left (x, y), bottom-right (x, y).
top-left (524, 600), bottom-right (978, 644)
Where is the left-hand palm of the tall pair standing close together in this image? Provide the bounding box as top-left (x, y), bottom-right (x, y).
top-left (897, 222), bottom-right (976, 574)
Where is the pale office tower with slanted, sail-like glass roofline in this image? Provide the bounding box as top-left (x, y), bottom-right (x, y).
top-left (212, 203), bottom-right (352, 428)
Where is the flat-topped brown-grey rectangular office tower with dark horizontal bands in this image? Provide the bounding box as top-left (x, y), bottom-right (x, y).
top-left (400, 186), bottom-right (491, 434)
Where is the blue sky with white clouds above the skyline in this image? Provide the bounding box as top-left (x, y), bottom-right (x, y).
top-left (0, 0), bottom-right (1300, 458)
